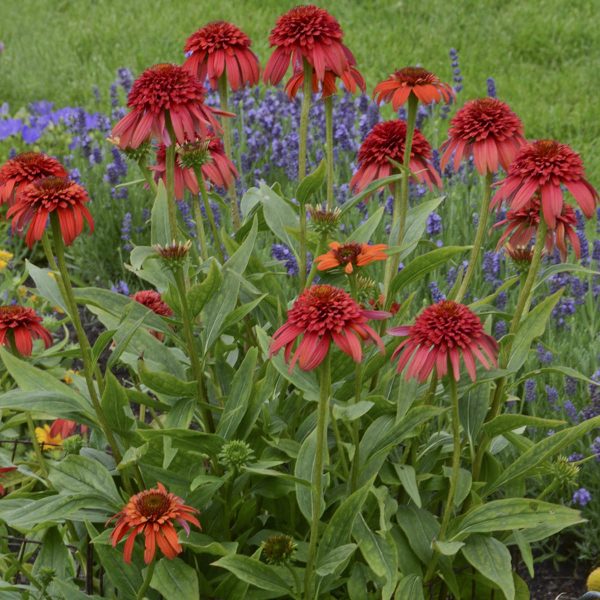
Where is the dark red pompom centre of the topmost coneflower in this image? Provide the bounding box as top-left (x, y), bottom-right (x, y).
top-left (269, 4), bottom-right (343, 48)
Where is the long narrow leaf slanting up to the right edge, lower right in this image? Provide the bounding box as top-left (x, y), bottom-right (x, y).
top-left (483, 416), bottom-right (600, 495)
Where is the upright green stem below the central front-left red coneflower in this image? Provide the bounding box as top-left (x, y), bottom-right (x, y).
top-left (304, 354), bottom-right (331, 600)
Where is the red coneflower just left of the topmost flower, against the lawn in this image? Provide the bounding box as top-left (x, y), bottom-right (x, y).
top-left (183, 21), bottom-right (260, 91)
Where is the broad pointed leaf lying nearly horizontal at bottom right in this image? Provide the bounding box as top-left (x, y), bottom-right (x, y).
top-left (450, 498), bottom-right (584, 541)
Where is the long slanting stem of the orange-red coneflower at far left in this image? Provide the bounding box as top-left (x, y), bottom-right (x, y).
top-left (50, 212), bottom-right (128, 468)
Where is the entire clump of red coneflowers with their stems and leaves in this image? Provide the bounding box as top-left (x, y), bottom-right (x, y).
top-left (0, 5), bottom-right (600, 600)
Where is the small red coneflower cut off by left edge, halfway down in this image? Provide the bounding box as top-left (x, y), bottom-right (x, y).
top-left (0, 306), bottom-right (52, 356)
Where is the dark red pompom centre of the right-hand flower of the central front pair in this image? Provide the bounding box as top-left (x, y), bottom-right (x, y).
top-left (410, 300), bottom-right (484, 348)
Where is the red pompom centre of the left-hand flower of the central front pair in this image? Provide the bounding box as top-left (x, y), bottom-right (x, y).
top-left (288, 285), bottom-right (363, 335)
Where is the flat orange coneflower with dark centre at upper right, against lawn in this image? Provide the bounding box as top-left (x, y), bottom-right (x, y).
top-left (373, 67), bottom-right (455, 110)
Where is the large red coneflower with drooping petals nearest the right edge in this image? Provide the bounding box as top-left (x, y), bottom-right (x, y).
top-left (492, 140), bottom-right (598, 229)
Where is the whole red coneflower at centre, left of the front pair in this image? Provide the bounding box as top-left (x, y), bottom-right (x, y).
top-left (269, 285), bottom-right (390, 372)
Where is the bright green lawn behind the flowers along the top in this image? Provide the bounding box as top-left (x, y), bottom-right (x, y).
top-left (0, 0), bottom-right (600, 175)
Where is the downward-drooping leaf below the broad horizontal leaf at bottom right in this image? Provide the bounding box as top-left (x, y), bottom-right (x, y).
top-left (462, 535), bottom-right (515, 600)
